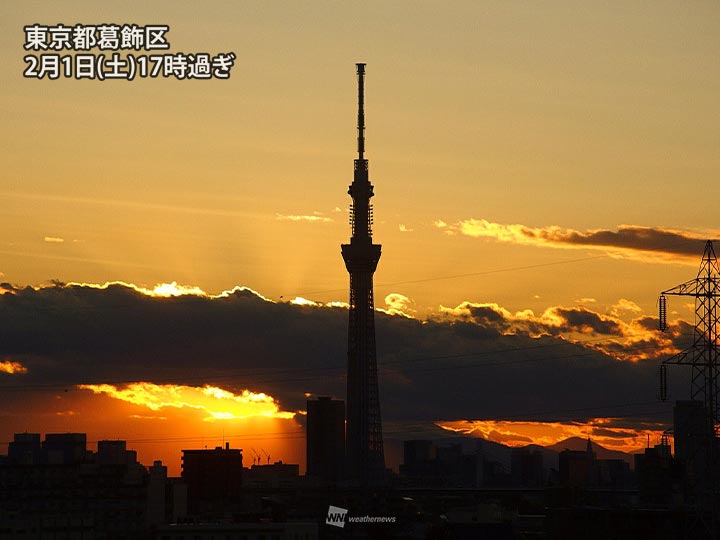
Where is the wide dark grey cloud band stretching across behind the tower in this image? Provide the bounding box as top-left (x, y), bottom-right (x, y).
top-left (0, 284), bottom-right (682, 430)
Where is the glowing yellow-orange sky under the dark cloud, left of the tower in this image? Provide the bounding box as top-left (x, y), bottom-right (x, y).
top-left (0, 383), bottom-right (305, 476)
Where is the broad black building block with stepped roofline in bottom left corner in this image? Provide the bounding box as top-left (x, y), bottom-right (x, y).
top-left (0, 433), bottom-right (151, 539)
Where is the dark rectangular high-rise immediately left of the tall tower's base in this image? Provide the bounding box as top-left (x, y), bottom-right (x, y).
top-left (307, 397), bottom-right (345, 482)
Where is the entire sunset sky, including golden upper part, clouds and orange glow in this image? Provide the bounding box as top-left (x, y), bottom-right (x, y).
top-left (0, 0), bottom-right (720, 472)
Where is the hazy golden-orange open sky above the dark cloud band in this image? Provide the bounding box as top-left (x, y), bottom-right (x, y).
top-left (0, 1), bottom-right (720, 313)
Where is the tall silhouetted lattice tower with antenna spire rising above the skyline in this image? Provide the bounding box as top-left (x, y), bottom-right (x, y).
top-left (342, 64), bottom-right (385, 485)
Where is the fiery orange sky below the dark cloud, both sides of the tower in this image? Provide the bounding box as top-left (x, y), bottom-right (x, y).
top-left (2, 376), bottom-right (664, 475)
